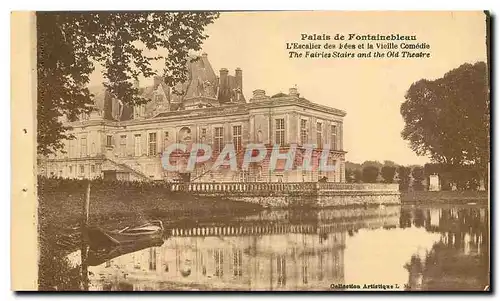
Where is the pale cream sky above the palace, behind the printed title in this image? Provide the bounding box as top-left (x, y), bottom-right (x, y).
top-left (91, 11), bottom-right (486, 165)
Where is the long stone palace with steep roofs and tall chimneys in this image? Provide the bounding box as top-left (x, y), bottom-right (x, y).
top-left (38, 54), bottom-right (346, 182)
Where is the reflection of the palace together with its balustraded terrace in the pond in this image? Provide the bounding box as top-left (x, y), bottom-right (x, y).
top-left (89, 207), bottom-right (399, 290)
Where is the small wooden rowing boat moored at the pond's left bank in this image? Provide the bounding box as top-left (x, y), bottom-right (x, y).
top-left (87, 220), bottom-right (164, 249)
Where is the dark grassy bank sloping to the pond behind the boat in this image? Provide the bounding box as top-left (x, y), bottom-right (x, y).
top-left (38, 180), bottom-right (260, 228)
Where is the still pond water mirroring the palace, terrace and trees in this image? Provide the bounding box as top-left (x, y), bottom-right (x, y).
top-left (78, 206), bottom-right (489, 291)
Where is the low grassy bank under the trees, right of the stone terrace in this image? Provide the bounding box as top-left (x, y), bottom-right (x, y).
top-left (401, 191), bottom-right (488, 204)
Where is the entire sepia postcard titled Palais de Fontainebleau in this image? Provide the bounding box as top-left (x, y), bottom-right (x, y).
top-left (11, 10), bottom-right (491, 293)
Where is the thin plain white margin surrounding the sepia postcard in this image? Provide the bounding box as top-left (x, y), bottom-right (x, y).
top-left (0, 0), bottom-right (499, 300)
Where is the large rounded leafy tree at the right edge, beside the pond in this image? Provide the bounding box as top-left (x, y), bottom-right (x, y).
top-left (401, 62), bottom-right (490, 180)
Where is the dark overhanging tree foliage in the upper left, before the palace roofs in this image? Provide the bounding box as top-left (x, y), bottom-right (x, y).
top-left (36, 11), bottom-right (218, 155)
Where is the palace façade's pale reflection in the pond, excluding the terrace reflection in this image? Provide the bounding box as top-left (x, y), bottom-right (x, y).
top-left (93, 225), bottom-right (346, 290)
